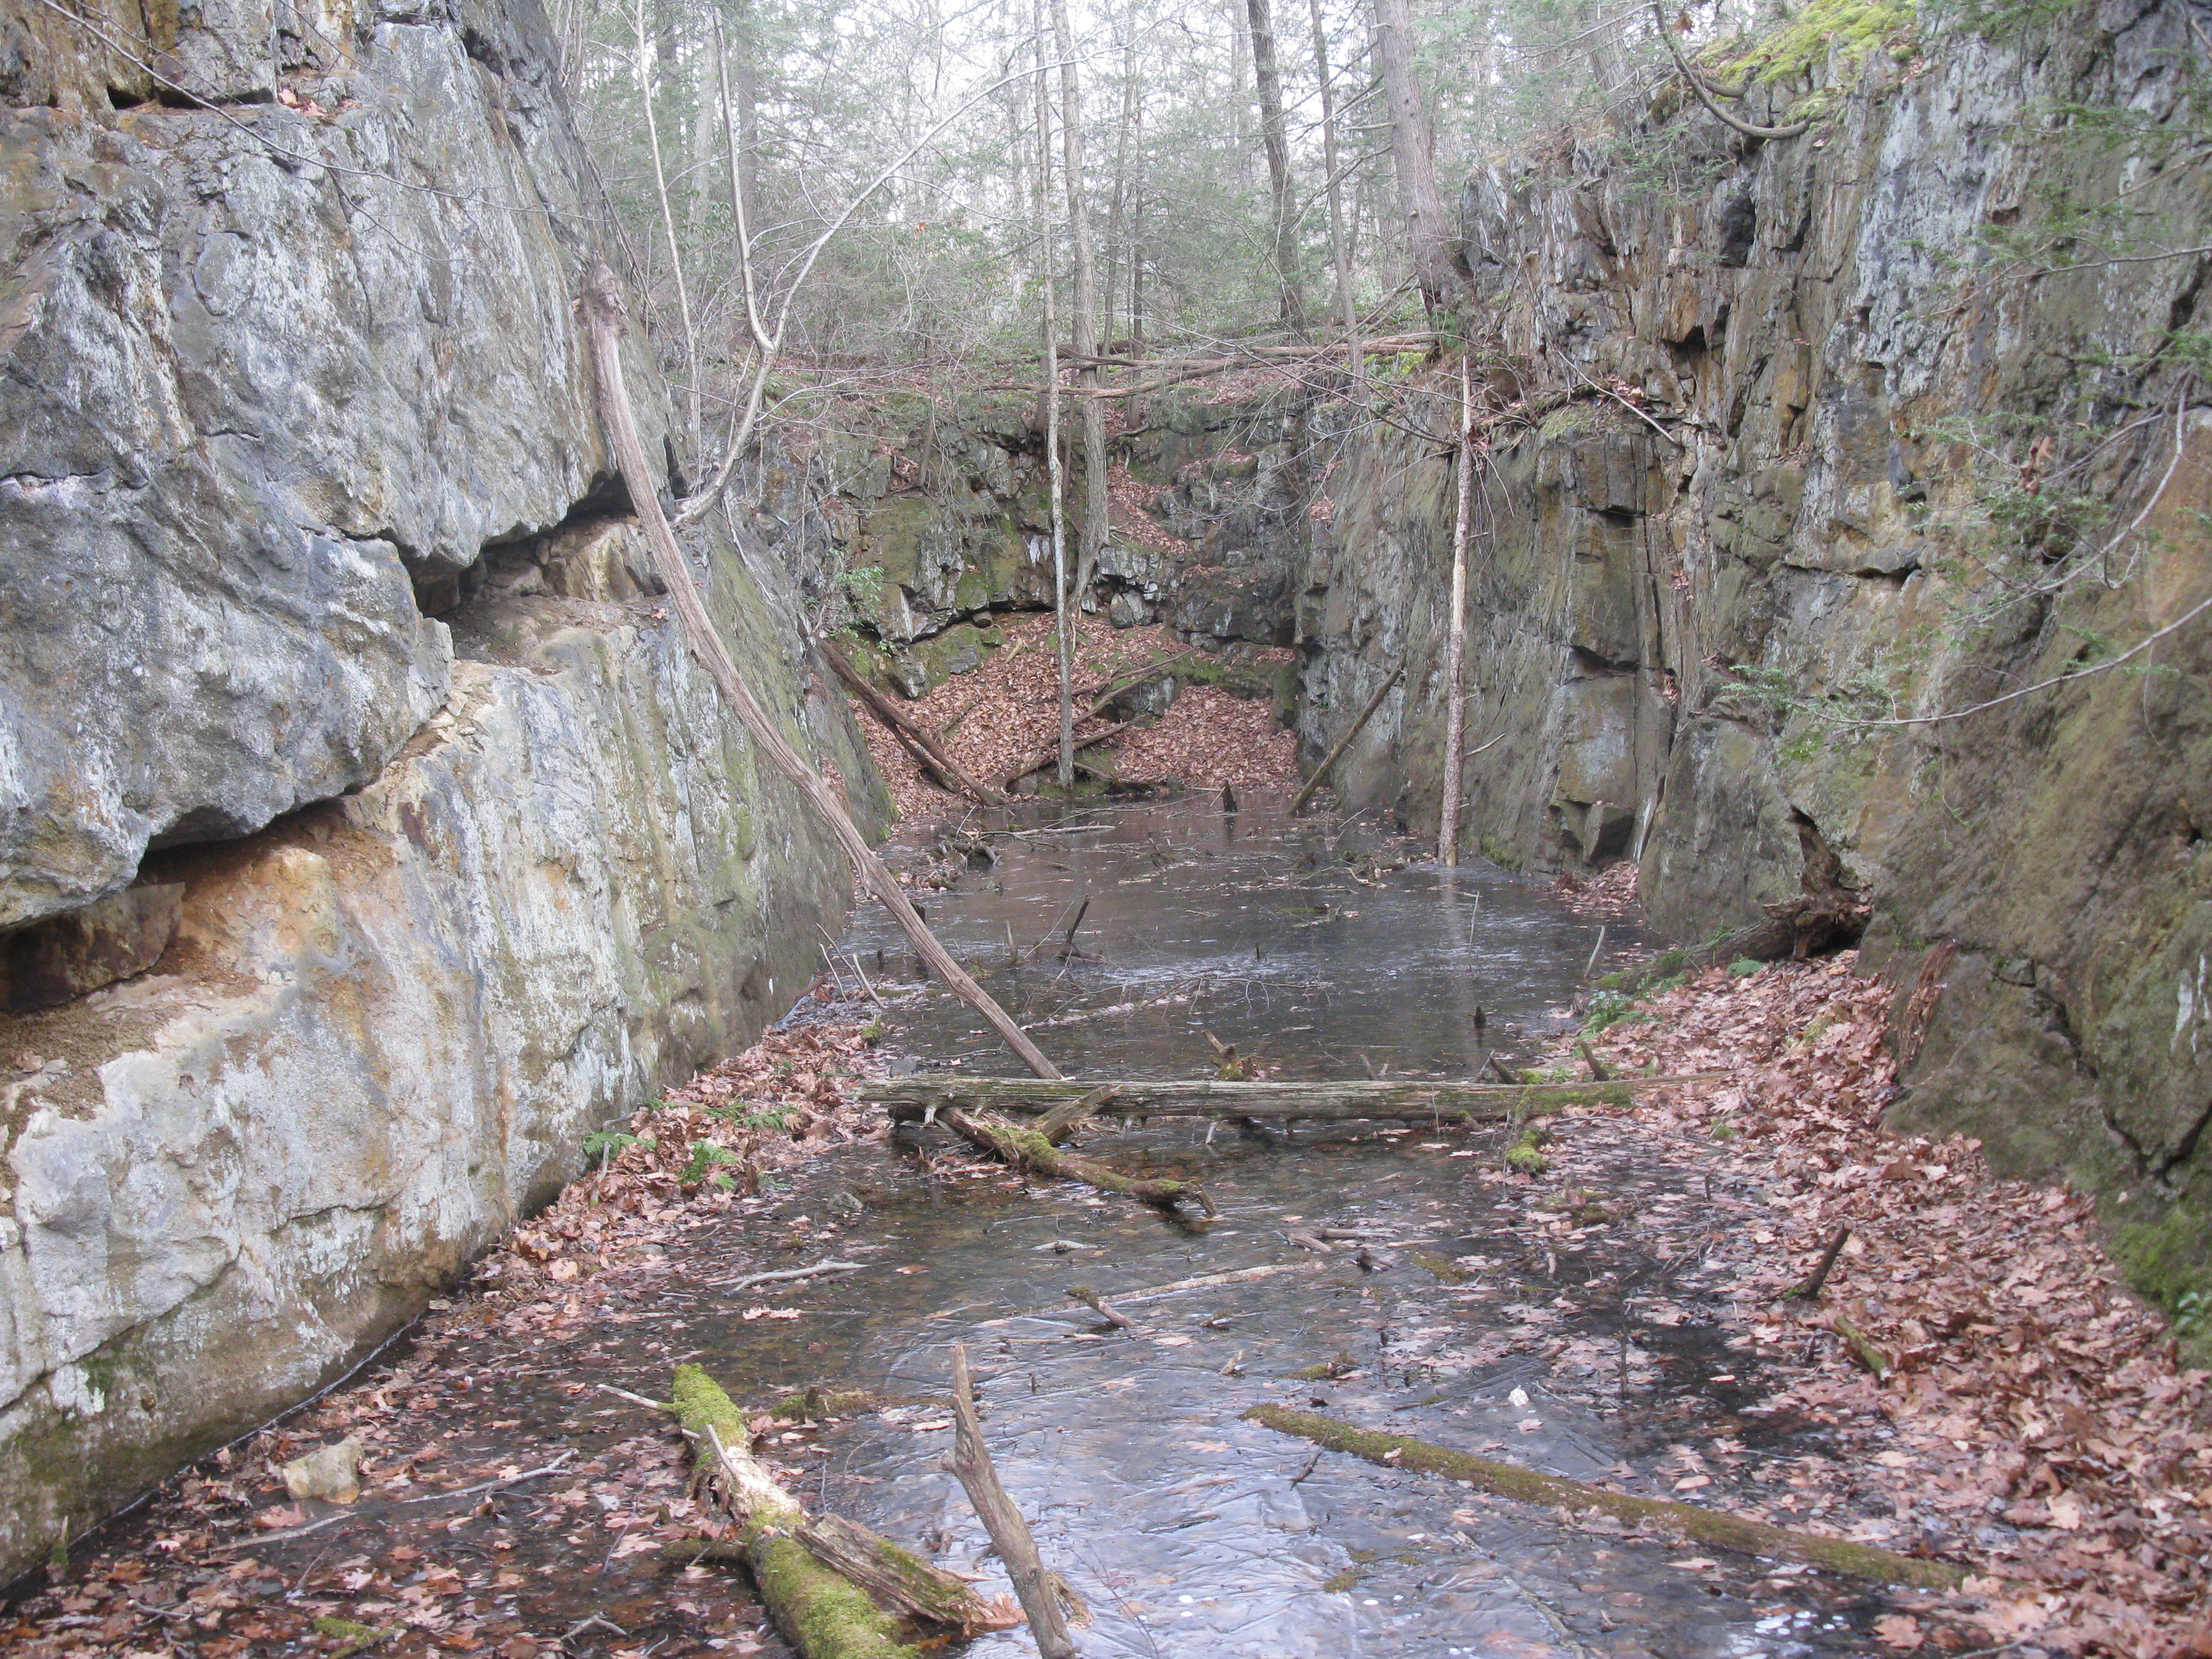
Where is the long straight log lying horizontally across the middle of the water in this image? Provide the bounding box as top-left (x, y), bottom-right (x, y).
top-left (851, 1071), bottom-right (1732, 1124)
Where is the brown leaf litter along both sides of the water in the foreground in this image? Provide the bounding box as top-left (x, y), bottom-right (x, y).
top-left (0, 929), bottom-right (2212, 1659)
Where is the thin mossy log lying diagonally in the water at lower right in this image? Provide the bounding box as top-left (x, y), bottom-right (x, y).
top-left (1245, 1404), bottom-right (1969, 1590)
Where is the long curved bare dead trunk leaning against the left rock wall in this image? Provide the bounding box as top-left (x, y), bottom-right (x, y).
top-left (581, 263), bottom-right (1059, 1093)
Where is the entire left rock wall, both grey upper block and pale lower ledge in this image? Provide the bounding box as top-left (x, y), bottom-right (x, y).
top-left (0, 0), bottom-right (887, 1575)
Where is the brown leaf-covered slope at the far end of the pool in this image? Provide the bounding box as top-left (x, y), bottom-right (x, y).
top-left (854, 611), bottom-right (1298, 820)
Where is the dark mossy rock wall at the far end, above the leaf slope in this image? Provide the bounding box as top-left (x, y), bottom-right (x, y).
top-left (725, 394), bottom-right (1310, 697)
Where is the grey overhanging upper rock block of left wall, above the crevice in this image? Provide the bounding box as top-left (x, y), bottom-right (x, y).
top-left (0, 0), bottom-right (666, 927)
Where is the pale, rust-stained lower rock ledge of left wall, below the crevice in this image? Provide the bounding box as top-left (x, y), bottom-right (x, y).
top-left (0, 528), bottom-right (885, 1570)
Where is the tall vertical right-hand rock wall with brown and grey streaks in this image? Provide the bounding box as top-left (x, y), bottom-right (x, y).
top-left (1301, 0), bottom-right (2212, 1296)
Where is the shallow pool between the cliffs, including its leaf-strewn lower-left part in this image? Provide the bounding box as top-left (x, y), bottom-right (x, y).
top-left (60, 789), bottom-right (1895, 1659)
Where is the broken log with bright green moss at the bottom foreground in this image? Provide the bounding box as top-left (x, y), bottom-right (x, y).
top-left (672, 1365), bottom-right (1015, 1659)
